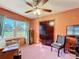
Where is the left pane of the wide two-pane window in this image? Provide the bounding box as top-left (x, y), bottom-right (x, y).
top-left (4, 18), bottom-right (14, 38)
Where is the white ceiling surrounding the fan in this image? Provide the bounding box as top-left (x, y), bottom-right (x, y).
top-left (0, 0), bottom-right (79, 18)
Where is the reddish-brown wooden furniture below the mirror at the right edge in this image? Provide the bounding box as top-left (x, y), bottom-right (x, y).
top-left (65, 36), bottom-right (79, 59)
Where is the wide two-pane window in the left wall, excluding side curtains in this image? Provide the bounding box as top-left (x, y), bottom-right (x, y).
top-left (3, 18), bottom-right (29, 39)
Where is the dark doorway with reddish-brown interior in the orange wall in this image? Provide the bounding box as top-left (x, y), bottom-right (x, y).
top-left (39, 20), bottom-right (55, 46)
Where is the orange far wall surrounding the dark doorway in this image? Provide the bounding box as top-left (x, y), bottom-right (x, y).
top-left (34, 8), bottom-right (79, 43)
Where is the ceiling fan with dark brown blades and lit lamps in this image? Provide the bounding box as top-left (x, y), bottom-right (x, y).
top-left (25, 0), bottom-right (52, 15)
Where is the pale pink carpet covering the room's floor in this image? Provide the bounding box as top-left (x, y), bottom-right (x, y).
top-left (21, 44), bottom-right (76, 59)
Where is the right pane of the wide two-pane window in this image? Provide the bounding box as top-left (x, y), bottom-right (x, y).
top-left (16, 21), bottom-right (26, 37)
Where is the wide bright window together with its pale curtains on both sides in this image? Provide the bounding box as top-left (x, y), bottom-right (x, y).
top-left (0, 15), bottom-right (29, 44)
